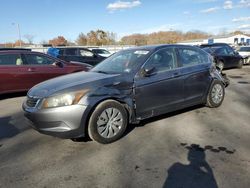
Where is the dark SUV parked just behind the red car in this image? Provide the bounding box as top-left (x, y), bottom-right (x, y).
top-left (47, 47), bottom-right (105, 66)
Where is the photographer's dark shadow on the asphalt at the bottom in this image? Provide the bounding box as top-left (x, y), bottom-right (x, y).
top-left (163, 144), bottom-right (218, 188)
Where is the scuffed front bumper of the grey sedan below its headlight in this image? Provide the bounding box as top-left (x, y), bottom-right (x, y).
top-left (23, 102), bottom-right (87, 138)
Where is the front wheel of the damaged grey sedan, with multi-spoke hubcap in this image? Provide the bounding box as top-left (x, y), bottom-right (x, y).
top-left (88, 100), bottom-right (128, 144)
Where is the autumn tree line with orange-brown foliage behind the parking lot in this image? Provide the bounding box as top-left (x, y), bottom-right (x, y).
top-left (2, 29), bottom-right (250, 47)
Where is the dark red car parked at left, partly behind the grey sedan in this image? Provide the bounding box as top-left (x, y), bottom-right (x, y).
top-left (0, 49), bottom-right (90, 94)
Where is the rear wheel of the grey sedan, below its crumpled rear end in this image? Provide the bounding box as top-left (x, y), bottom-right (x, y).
top-left (206, 80), bottom-right (225, 108)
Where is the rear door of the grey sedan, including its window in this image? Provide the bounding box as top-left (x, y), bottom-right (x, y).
top-left (178, 47), bottom-right (211, 106)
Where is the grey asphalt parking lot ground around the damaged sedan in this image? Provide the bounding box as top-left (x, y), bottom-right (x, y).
top-left (0, 66), bottom-right (250, 188)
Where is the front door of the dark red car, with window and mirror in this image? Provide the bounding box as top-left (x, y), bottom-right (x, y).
top-left (22, 54), bottom-right (67, 87)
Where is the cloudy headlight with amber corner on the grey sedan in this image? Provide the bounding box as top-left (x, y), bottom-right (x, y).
top-left (42, 90), bottom-right (88, 108)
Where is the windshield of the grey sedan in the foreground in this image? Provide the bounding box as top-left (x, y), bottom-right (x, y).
top-left (91, 50), bottom-right (149, 74)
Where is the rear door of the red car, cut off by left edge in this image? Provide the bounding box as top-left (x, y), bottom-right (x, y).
top-left (0, 53), bottom-right (29, 93)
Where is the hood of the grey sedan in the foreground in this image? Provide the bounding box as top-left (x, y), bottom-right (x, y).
top-left (28, 72), bottom-right (128, 98)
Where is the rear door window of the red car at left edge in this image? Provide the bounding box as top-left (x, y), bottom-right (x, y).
top-left (0, 54), bottom-right (23, 65)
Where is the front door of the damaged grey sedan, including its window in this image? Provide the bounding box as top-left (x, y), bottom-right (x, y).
top-left (135, 47), bottom-right (183, 119)
